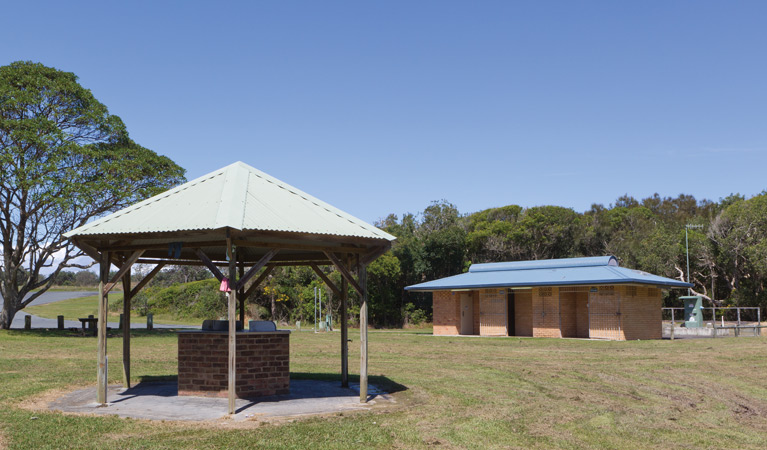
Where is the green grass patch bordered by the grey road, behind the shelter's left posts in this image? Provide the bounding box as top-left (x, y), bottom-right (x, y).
top-left (24, 292), bottom-right (202, 325)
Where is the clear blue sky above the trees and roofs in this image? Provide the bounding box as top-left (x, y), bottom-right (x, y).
top-left (0, 1), bottom-right (767, 222)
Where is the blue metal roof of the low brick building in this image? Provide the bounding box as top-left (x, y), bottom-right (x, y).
top-left (405, 256), bottom-right (692, 291)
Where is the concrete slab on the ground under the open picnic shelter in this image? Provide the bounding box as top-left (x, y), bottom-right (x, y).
top-left (49, 380), bottom-right (394, 421)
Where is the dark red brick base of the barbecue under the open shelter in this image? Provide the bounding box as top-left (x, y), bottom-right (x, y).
top-left (178, 332), bottom-right (290, 398)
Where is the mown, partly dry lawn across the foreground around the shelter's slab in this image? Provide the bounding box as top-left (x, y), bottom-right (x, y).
top-left (0, 331), bottom-right (767, 450)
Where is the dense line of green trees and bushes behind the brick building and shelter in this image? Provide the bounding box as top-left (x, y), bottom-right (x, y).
top-left (49, 192), bottom-right (767, 327)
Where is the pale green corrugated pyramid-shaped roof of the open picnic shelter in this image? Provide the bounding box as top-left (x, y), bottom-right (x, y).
top-left (64, 161), bottom-right (395, 241)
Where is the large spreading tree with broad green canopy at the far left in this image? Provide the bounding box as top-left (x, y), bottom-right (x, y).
top-left (0, 62), bottom-right (184, 328)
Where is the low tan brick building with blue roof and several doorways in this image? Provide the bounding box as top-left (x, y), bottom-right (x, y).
top-left (405, 256), bottom-right (692, 340)
